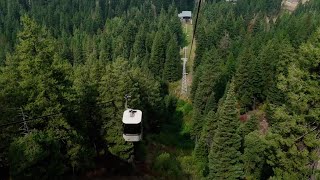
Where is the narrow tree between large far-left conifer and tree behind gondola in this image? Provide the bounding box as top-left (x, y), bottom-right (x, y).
top-left (71, 53), bottom-right (105, 152)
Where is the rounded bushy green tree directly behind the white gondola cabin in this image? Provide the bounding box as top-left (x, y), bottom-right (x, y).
top-left (99, 59), bottom-right (162, 159)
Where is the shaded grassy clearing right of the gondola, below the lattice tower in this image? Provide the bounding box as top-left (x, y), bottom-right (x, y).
top-left (148, 100), bottom-right (194, 178)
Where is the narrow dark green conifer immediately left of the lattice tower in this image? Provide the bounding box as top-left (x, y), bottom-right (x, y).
top-left (163, 38), bottom-right (182, 82)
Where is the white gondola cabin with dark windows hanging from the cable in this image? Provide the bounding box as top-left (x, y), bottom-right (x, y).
top-left (122, 109), bottom-right (142, 142)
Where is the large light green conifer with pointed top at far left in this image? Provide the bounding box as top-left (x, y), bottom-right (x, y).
top-left (2, 16), bottom-right (71, 116)
